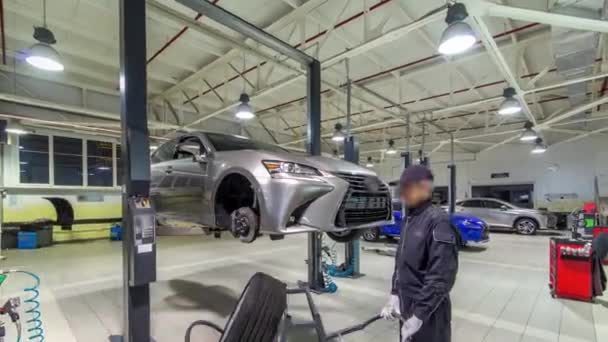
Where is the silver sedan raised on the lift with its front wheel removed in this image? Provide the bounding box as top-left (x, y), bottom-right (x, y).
top-left (151, 132), bottom-right (392, 242)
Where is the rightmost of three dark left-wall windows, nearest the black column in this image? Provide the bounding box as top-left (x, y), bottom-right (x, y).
top-left (87, 140), bottom-right (114, 186)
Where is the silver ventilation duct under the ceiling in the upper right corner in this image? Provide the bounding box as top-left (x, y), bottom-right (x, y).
top-left (551, 0), bottom-right (608, 126)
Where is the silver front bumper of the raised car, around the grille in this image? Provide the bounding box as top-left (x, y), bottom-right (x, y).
top-left (258, 175), bottom-right (392, 234)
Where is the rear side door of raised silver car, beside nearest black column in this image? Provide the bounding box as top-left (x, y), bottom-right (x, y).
top-left (150, 139), bottom-right (177, 218)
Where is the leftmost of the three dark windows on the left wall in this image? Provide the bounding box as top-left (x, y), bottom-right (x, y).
top-left (19, 134), bottom-right (49, 184)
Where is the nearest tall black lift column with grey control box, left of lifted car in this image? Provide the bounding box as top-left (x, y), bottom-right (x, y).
top-left (120, 0), bottom-right (156, 342)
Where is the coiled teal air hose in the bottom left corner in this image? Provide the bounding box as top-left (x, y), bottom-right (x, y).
top-left (0, 270), bottom-right (44, 342)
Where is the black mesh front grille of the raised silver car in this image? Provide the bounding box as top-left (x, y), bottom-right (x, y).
top-left (335, 173), bottom-right (392, 227)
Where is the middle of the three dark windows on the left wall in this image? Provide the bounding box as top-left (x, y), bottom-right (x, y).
top-left (53, 137), bottom-right (83, 185)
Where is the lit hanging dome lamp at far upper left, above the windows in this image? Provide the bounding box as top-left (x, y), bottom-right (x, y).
top-left (25, 0), bottom-right (64, 71)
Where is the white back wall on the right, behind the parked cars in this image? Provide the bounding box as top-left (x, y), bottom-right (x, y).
top-left (376, 135), bottom-right (608, 211)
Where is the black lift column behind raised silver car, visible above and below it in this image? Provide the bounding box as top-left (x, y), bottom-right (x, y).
top-left (307, 60), bottom-right (325, 291)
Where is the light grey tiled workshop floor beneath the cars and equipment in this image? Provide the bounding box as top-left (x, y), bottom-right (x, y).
top-left (0, 233), bottom-right (608, 342)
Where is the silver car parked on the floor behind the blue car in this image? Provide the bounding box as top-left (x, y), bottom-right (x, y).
top-left (456, 197), bottom-right (557, 235)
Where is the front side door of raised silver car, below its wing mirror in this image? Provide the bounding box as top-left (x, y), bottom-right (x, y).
top-left (170, 136), bottom-right (209, 223)
